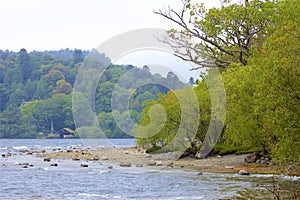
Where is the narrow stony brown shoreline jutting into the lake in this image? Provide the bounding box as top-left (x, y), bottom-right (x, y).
top-left (36, 147), bottom-right (300, 176)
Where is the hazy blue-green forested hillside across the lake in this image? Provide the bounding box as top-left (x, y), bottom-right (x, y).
top-left (0, 49), bottom-right (183, 138)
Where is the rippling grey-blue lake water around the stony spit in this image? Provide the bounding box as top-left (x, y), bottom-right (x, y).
top-left (0, 139), bottom-right (299, 200)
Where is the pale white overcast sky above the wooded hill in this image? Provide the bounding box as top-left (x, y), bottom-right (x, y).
top-left (0, 0), bottom-right (220, 80)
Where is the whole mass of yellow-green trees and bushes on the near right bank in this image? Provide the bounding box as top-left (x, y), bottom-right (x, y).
top-left (137, 0), bottom-right (300, 163)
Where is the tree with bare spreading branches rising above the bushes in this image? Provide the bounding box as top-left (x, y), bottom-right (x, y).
top-left (155, 0), bottom-right (276, 69)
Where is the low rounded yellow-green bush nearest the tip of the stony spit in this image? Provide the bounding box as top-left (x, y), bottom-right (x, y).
top-left (132, 88), bottom-right (201, 149)
